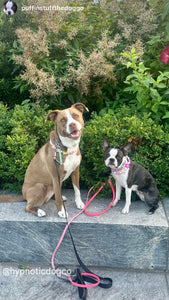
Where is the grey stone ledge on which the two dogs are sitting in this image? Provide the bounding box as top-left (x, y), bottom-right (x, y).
top-left (0, 190), bottom-right (169, 271)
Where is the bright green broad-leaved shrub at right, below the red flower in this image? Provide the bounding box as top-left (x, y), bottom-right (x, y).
top-left (122, 48), bottom-right (169, 123)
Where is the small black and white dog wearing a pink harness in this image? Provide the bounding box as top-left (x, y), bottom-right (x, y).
top-left (103, 139), bottom-right (159, 214)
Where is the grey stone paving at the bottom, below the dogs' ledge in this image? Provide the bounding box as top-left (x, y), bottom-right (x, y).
top-left (0, 263), bottom-right (169, 300)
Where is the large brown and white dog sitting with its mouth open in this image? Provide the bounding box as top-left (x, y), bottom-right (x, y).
top-left (0, 103), bottom-right (88, 218)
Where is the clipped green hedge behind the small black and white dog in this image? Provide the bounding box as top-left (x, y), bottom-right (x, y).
top-left (81, 106), bottom-right (169, 195)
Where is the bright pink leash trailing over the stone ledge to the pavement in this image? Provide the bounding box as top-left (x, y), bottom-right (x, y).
top-left (51, 180), bottom-right (115, 288)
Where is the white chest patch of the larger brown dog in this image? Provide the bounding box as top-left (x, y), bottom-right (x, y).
top-left (63, 153), bottom-right (81, 181)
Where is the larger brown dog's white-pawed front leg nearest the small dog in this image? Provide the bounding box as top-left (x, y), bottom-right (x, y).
top-left (71, 167), bottom-right (84, 209)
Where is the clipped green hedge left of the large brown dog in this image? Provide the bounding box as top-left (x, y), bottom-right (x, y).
top-left (0, 101), bottom-right (54, 190)
